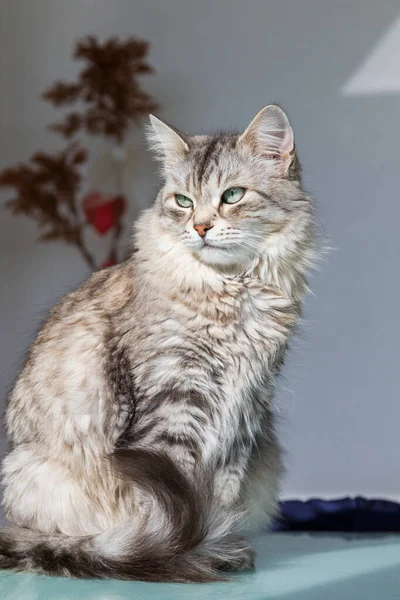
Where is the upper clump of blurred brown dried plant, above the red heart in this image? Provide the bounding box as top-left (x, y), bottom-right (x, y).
top-left (43, 36), bottom-right (157, 142)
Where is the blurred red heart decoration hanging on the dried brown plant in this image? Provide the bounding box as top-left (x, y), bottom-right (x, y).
top-left (82, 192), bottom-right (126, 235)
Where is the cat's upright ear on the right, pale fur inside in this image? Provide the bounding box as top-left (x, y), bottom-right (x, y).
top-left (239, 104), bottom-right (295, 175)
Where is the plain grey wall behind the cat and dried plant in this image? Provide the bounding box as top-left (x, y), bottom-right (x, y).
top-left (0, 0), bottom-right (400, 510)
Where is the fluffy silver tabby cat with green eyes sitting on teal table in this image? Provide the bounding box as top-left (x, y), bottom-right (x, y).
top-left (0, 105), bottom-right (315, 582)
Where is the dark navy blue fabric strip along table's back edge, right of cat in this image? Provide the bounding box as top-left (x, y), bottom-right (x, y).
top-left (272, 497), bottom-right (400, 533)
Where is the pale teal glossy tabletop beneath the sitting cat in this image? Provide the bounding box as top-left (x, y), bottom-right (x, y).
top-left (0, 533), bottom-right (400, 600)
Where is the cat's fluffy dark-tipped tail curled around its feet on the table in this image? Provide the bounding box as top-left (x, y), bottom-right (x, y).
top-left (0, 450), bottom-right (252, 582)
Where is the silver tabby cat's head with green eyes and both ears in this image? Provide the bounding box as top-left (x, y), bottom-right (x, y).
top-left (149, 105), bottom-right (311, 270)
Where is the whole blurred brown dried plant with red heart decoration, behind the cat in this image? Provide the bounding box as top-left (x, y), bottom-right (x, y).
top-left (0, 36), bottom-right (157, 269)
